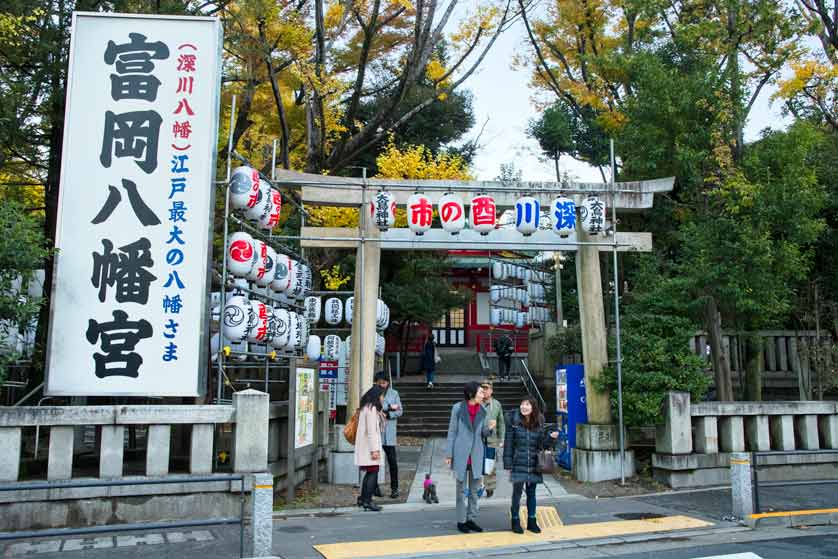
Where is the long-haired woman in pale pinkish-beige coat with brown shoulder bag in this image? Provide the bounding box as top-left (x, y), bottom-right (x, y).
top-left (355, 385), bottom-right (384, 511)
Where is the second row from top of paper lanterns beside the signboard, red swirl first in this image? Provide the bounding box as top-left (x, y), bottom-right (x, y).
top-left (226, 231), bottom-right (314, 299)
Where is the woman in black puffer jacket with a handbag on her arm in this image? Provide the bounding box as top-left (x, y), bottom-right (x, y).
top-left (503, 398), bottom-right (559, 534)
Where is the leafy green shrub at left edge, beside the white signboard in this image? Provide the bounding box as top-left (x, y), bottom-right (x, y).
top-left (0, 201), bottom-right (49, 382)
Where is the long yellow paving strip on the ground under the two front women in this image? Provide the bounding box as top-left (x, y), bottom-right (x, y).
top-left (314, 509), bottom-right (712, 559)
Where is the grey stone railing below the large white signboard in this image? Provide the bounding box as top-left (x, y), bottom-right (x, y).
top-left (0, 390), bottom-right (328, 531)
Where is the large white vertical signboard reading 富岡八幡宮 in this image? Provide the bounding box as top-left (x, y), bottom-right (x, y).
top-left (47, 13), bottom-right (221, 396)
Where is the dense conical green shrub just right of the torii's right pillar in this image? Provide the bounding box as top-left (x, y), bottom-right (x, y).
top-left (597, 256), bottom-right (710, 426)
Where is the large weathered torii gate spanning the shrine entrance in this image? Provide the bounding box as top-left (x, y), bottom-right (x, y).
top-left (276, 170), bottom-right (674, 481)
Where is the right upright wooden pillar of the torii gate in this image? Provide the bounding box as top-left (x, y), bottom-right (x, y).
top-left (576, 223), bottom-right (611, 425)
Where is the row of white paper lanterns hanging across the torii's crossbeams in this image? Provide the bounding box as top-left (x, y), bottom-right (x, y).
top-left (378, 190), bottom-right (605, 237)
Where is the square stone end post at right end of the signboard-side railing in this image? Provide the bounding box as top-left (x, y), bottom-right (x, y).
top-left (233, 389), bottom-right (270, 473)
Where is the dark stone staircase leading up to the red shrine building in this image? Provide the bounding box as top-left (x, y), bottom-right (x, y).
top-left (396, 382), bottom-right (527, 437)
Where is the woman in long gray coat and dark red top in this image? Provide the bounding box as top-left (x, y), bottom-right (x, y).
top-left (445, 382), bottom-right (496, 533)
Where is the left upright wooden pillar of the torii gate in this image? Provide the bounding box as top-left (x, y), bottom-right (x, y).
top-left (347, 206), bottom-right (381, 413)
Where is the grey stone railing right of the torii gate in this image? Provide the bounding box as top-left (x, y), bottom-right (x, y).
top-left (652, 392), bottom-right (838, 487)
